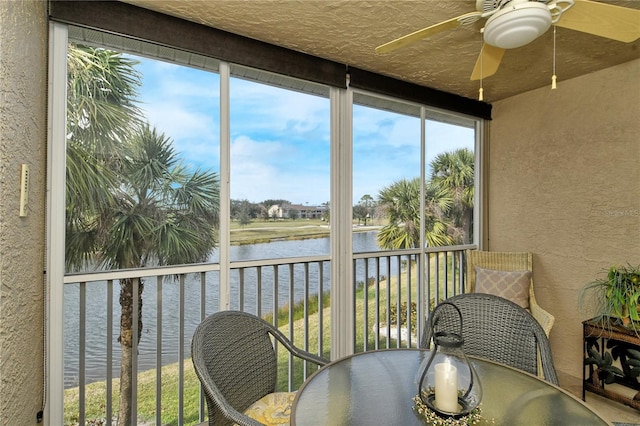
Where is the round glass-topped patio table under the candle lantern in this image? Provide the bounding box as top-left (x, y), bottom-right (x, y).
top-left (291, 349), bottom-right (610, 426)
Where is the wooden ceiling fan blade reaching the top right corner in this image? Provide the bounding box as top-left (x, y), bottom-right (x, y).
top-left (556, 0), bottom-right (640, 43)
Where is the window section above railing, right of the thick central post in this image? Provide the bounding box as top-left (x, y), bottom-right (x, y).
top-left (353, 93), bottom-right (476, 252)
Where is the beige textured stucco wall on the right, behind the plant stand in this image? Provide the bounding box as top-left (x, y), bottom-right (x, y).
top-left (488, 59), bottom-right (640, 386)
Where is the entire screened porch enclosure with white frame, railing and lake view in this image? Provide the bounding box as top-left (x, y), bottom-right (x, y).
top-left (49, 18), bottom-right (483, 425)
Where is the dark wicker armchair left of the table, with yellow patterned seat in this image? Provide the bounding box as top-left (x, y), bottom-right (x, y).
top-left (191, 311), bottom-right (328, 426)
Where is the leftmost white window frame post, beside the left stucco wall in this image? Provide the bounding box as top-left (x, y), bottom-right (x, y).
top-left (44, 23), bottom-right (68, 425)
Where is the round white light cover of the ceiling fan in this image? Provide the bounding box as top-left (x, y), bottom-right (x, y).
top-left (484, 2), bottom-right (551, 49)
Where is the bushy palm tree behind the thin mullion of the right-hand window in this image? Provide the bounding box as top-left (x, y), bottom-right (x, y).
top-left (377, 178), bottom-right (451, 249)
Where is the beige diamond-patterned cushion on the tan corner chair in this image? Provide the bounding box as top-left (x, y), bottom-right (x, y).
top-left (476, 266), bottom-right (531, 309)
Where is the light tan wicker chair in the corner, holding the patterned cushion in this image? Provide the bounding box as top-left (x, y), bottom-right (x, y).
top-left (466, 250), bottom-right (555, 337)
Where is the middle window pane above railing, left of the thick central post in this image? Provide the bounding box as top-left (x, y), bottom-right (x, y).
top-left (230, 72), bottom-right (331, 261)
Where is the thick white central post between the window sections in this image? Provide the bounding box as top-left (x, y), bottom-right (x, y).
top-left (330, 88), bottom-right (355, 359)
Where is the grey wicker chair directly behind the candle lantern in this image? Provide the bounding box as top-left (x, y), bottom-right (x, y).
top-left (420, 293), bottom-right (558, 385)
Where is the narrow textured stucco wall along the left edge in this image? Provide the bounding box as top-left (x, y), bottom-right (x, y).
top-left (0, 0), bottom-right (47, 426)
